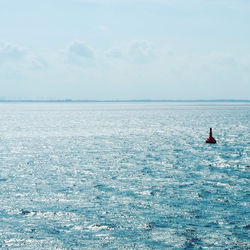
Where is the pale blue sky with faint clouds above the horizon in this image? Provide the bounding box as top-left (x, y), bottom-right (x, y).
top-left (0, 0), bottom-right (250, 100)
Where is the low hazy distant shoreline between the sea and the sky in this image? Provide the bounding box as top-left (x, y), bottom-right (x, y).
top-left (0, 99), bottom-right (250, 103)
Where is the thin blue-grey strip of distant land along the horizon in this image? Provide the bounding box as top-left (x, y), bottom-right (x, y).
top-left (0, 99), bottom-right (250, 103)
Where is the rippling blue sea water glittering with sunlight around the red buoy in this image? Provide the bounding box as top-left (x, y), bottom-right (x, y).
top-left (0, 103), bottom-right (250, 249)
